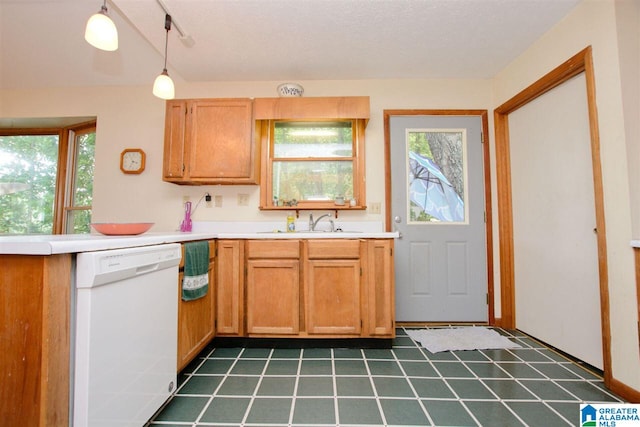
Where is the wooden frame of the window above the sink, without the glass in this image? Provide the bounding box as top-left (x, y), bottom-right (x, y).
top-left (255, 118), bottom-right (367, 215)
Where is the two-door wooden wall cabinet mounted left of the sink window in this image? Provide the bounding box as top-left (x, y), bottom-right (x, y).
top-left (163, 98), bottom-right (260, 185)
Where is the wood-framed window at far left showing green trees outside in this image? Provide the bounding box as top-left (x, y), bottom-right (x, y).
top-left (0, 124), bottom-right (95, 234)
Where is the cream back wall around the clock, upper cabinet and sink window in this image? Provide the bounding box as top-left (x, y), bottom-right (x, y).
top-left (0, 80), bottom-right (491, 231)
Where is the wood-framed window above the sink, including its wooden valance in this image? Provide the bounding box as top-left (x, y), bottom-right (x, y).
top-left (254, 97), bottom-right (369, 211)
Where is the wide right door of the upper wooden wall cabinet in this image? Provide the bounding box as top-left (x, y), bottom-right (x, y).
top-left (189, 99), bottom-right (257, 184)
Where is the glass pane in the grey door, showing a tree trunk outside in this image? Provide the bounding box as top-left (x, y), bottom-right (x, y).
top-left (406, 129), bottom-right (467, 223)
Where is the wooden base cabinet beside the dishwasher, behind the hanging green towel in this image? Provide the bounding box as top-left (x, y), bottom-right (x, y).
top-left (178, 240), bottom-right (216, 372)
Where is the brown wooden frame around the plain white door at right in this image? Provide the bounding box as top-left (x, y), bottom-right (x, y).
top-left (494, 46), bottom-right (612, 387)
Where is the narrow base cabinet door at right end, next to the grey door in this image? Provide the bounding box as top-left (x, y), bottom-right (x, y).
top-left (365, 240), bottom-right (395, 337)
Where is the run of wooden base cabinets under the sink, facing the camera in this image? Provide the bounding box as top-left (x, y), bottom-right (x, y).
top-left (216, 239), bottom-right (395, 338)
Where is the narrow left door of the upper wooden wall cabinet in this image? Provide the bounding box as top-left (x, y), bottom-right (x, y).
top-left (162, 100), bottom-right (187, 180)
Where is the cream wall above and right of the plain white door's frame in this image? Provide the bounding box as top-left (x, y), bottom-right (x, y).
top-left (494, 0), bottom-right (640, 390)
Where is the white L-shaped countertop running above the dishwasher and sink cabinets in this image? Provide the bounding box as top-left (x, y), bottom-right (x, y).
top-left (0, 222), bottom-right (398, 255)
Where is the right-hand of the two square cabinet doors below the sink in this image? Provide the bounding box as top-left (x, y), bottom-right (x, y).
top-left (305, 259), bottom-right (361, 335)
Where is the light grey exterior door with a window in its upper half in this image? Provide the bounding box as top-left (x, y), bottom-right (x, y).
top-left (389, 115), bottom-right (488, 322)
